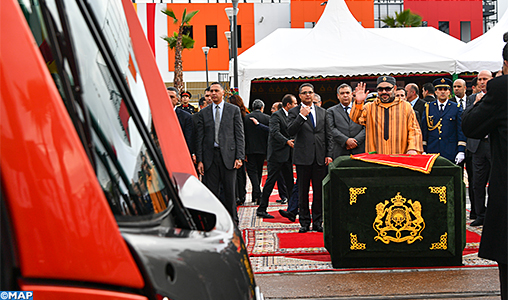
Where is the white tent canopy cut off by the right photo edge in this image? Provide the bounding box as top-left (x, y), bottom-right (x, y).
top-left (456, 12), bottom-right (508, 73)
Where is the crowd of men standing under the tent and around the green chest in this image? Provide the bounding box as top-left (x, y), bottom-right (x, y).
top-left (172, 42), bottom-right (508, 295)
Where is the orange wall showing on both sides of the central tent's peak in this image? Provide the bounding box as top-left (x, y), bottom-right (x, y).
top-left (291, 0), bottom-right (374, 28)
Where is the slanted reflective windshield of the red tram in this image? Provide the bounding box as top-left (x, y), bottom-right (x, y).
top-left (27, 0), bottom-right (177, 221)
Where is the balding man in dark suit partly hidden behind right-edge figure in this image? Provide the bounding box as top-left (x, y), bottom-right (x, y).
top-left (466, 70), bottom-right (492, 226)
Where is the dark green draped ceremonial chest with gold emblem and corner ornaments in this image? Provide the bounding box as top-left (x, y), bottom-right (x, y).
top-left (323, 156), bottom-right (466, 268)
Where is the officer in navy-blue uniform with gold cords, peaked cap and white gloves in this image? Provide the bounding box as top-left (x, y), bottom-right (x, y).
top-left (421, 78), bottom-right (466, 164)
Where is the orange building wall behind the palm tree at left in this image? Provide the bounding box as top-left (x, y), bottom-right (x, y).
top-left (167, 3), bottom-right (255, 71)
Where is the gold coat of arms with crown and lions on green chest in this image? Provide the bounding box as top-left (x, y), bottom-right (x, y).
top-left (372, 192), bottom-right (425, 244)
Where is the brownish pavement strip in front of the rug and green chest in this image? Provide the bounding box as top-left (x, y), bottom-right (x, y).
top-left (247, 180), bottom-right (501, 300)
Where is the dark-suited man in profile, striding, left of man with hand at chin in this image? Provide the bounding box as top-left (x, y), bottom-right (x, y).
top-left (256, 94), bottom-right (298, 218)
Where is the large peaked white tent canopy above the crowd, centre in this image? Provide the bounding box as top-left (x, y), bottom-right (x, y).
top-left (238, 0), bottom-right (455, 101)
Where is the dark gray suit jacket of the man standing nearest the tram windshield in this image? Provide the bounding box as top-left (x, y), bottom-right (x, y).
top-left (196, 102), bottom-right (245, 171)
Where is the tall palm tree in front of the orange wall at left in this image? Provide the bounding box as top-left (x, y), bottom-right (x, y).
top-left (161, 9), bottom-right (199, 92)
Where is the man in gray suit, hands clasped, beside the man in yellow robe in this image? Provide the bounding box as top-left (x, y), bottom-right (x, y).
top-left (326, 83), bottom-right (365, 159)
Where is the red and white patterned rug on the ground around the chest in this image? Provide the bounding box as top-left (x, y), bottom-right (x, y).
top-left (238, 173), bottom-right (497, 274)
